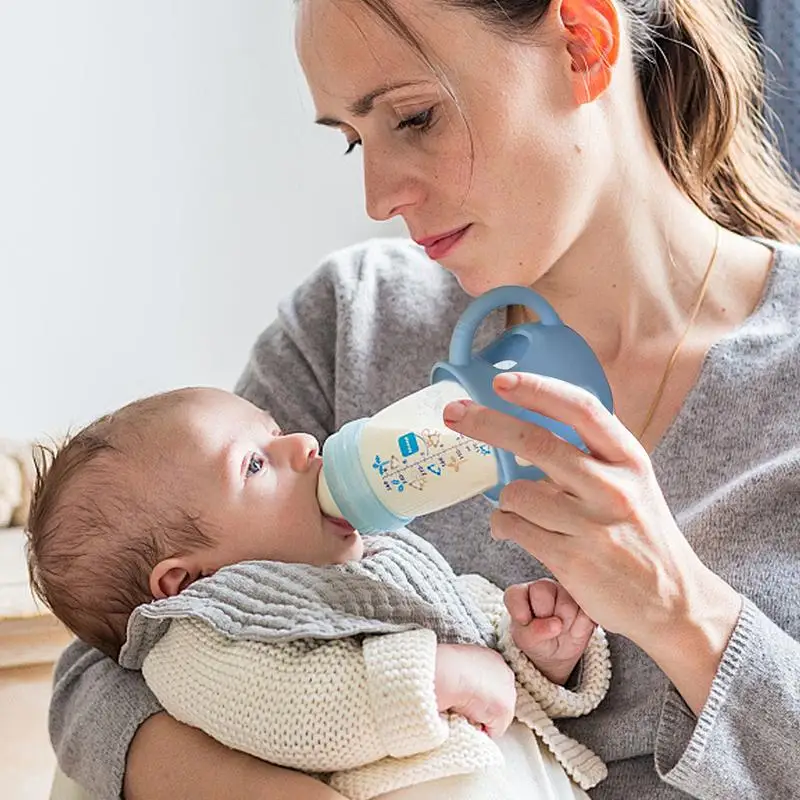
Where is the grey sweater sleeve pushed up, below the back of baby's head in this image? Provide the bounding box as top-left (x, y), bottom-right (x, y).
top-left (50, 639), bottom-right (163, 800)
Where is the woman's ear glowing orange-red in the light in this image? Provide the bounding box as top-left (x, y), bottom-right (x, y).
top-left (560, 0), bottom-right (620, 104)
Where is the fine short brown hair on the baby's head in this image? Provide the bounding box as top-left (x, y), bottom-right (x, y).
top-left (27, 392), bottom-right (214, 658)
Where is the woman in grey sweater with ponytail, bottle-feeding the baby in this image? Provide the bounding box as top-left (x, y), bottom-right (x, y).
top-left (52, 0), bottom-right (800, 800)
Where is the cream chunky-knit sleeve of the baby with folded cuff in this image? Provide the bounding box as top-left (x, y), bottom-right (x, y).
top-left (142, 620), bottom-right (448, 772)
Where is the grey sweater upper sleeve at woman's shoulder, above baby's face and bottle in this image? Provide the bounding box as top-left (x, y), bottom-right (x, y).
top-left (228, 239), bottom-right (472, 442)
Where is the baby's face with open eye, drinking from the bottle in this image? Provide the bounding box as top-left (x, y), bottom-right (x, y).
top-left (151, 389), bottom-right (363, 588)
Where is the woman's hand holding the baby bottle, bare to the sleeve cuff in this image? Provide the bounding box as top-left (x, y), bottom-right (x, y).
top-left (444, 373), bottom-right (740, 705)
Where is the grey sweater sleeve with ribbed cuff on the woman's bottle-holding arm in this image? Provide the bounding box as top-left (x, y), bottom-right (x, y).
top-left (655, 599), bottom-right (800, 800)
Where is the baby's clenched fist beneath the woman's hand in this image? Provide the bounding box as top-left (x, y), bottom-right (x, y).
top-left (504, 578), bottom-right (595, 686)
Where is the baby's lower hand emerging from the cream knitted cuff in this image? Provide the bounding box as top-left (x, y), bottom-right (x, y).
top-left (434, 644), bottom-right (517, 738)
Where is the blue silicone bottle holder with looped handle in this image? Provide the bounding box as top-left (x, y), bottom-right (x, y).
top-left (431, 286), bottom-right (613, 502)
